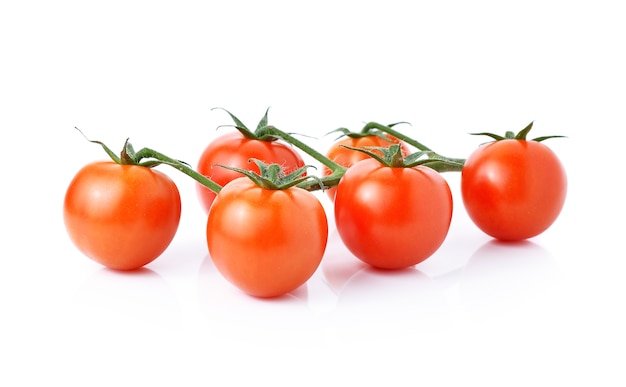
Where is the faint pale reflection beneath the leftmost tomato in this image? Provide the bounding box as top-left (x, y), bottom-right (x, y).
top-left (75, 267), bottom-right (181, 327)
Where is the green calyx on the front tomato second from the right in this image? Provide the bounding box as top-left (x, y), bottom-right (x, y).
top-left (342, 144), bottom-right (463, 172)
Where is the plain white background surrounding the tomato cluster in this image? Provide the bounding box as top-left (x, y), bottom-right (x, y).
top-left (0, 0), bottom-right (626, 386)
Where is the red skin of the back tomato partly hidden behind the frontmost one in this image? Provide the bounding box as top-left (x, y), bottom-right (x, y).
top-left (196, 132), bottom-right (304, 214)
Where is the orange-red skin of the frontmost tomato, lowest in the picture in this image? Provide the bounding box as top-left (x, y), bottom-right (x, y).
top-left (206, 177), bottom-right (328, 297)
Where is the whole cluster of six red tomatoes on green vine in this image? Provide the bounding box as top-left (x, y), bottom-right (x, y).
top-left (64, 111), bottom-right (567, 297)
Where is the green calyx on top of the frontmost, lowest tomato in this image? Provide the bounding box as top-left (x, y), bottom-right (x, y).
top-left (218, 158), bottom-right (323, 190)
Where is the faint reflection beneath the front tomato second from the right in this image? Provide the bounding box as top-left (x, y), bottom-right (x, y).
top-left (322, 233), bottom-right (449, 337)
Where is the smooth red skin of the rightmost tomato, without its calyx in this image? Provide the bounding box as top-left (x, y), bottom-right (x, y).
top-left (461, 140), bottom-right (567, 241)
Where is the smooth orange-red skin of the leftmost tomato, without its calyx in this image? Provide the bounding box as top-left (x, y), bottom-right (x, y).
top-left (63, 161), bottom-right (181, 270)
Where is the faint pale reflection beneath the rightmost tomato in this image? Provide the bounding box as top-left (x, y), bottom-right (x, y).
top-left (459, 240), bottom-right (558, 316)
